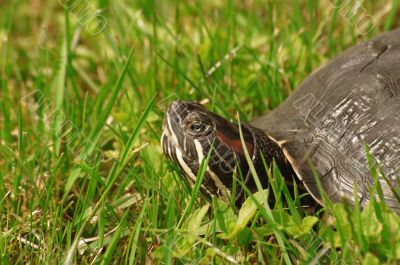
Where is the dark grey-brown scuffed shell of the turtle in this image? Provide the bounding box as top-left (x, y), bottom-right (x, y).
top-left (251, 30), bottom-right (400, 212)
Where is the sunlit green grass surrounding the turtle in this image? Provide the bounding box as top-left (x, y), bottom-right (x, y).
top-left (0, 0), bottom-right (400, 264)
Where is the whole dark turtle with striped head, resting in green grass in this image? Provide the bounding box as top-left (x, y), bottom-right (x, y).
top-left (161, 30), bottom-right (400, 213)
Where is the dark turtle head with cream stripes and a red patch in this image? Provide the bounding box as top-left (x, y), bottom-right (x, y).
top-left (161, 101), bottom-right (255, 196)
